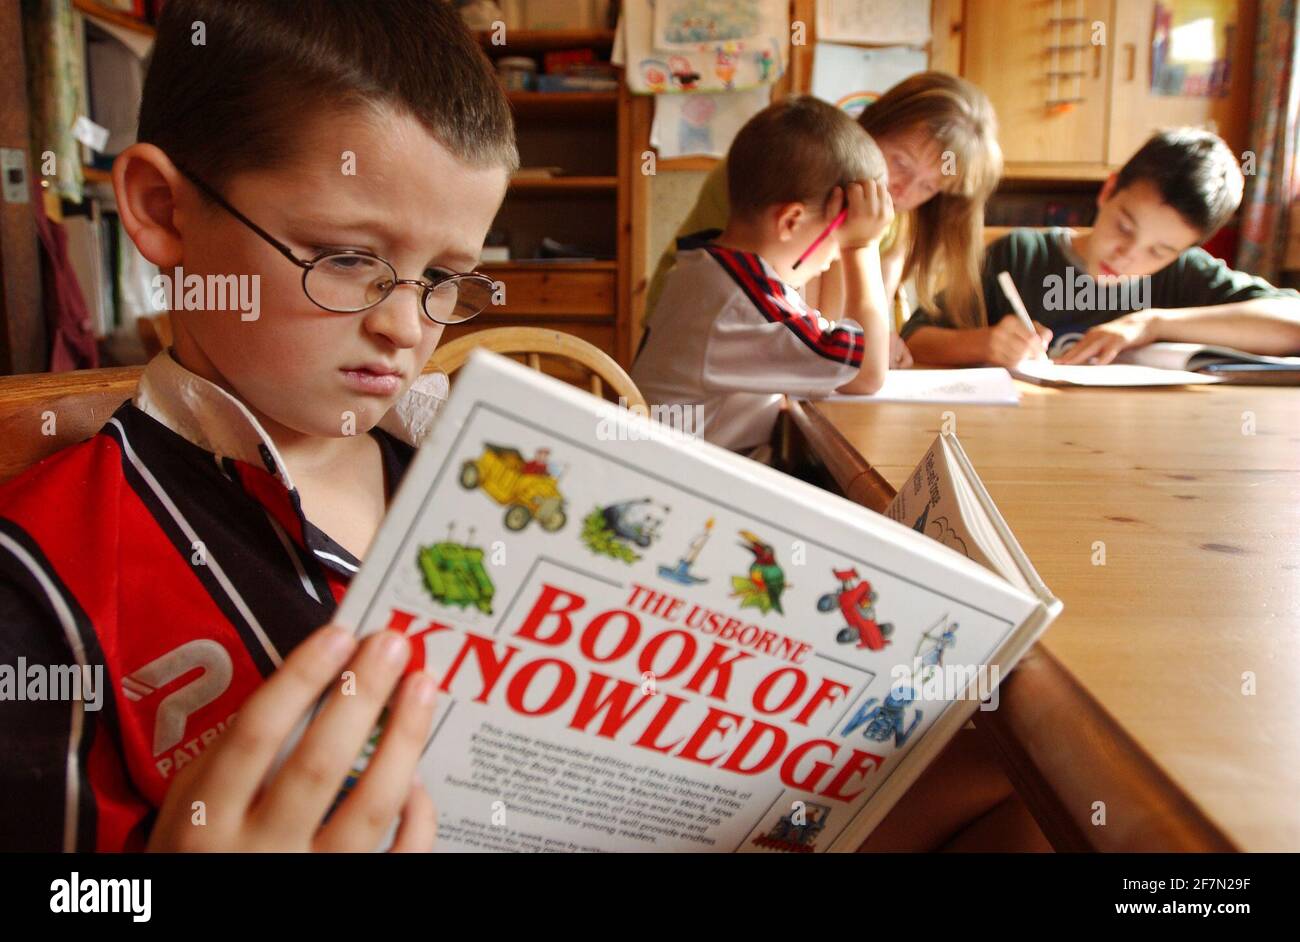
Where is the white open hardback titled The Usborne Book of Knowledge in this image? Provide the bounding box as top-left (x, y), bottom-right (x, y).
top-left (335, 351), bottom-right (1061, 852)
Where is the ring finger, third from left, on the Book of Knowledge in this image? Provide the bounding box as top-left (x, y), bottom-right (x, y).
top-left (313, 673), bottom-right (436, 851)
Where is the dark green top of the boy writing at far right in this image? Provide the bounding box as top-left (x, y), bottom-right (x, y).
top-left (902, 229), bottom-right (1300, 351)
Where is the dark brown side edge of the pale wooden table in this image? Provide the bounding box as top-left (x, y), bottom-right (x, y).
top-left (787, 400), bottom-right (1240, 852)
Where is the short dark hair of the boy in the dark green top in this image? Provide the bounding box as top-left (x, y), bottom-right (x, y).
top-left (1115, 127), bottom-right (1245, 239)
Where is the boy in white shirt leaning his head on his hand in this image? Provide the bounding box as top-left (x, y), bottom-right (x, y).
top-left (632, 96), bottom-right (893, 459)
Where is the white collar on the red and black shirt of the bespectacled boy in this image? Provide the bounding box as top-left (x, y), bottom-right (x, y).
top-left (133, 350), bottom-right (449, 490)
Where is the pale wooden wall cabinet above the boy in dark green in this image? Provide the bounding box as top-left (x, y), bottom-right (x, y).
top-left (949, 0), bottom-right (1257, 179)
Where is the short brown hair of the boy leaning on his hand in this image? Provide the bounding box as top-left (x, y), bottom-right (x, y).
top-left (727, 95), bottom-right (885, 217)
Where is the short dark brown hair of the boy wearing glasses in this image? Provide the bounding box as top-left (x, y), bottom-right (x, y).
top-left (139, 0), bottom-right (519, 185)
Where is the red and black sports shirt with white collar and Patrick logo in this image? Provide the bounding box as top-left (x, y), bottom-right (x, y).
top-left (0, 353), bottom-right (442, 850)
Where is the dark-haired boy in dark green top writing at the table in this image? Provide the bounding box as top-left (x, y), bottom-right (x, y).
top-left (902, 127), bottom-right (1300, 366)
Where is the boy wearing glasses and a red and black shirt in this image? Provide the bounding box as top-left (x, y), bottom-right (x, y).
top-left (0, 0), bottom-right (517, 850)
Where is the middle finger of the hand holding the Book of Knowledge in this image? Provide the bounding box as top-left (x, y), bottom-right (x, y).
top-left (254, 631), bottom-right (411, 835)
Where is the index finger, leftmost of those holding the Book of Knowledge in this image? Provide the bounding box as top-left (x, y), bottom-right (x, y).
top-left (200, 625), bottom-right (356, 813)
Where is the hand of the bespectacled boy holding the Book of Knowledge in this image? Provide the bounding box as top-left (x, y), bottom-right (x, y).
top-left (148, 625), bottom-right (437, 851)
